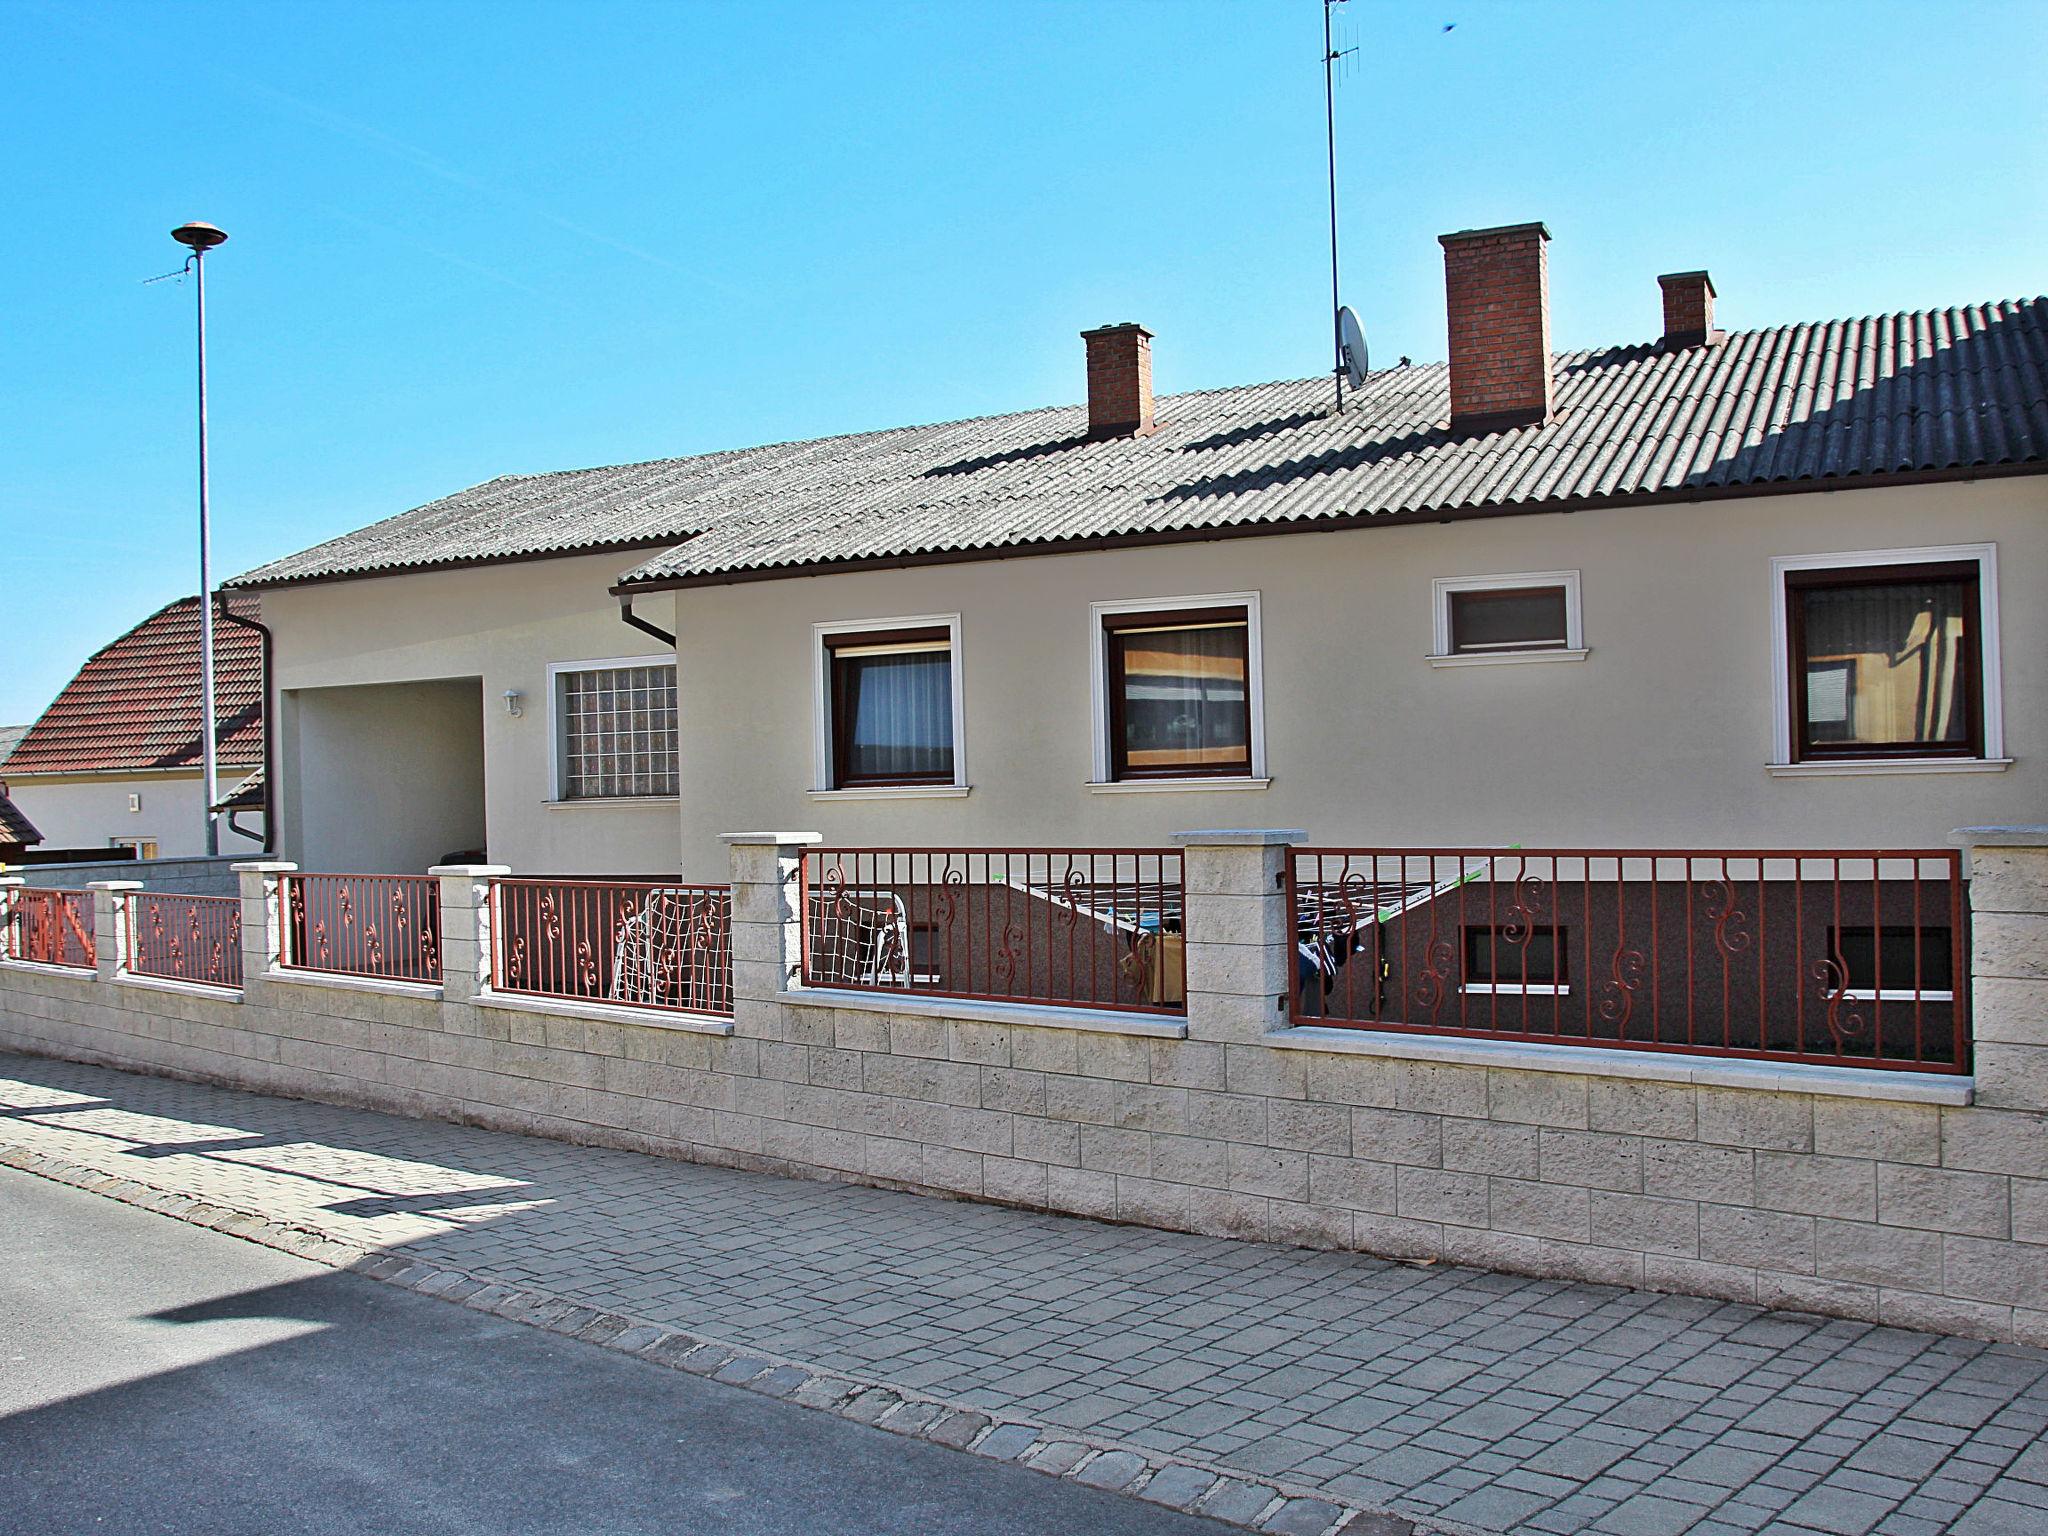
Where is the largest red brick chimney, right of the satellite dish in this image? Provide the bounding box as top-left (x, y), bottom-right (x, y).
top-left (1440, 223), bottom-right (1550, 432)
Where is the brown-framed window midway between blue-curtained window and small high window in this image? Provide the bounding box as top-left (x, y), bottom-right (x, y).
top-left (1102, 606), bottom-right (1251, 780)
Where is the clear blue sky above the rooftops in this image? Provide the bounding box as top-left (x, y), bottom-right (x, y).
top-left (0, 0), bottom-right (2048, 721)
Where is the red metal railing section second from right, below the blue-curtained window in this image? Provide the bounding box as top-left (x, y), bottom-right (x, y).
top-left (799, 848), bottom-right (1186, 1014)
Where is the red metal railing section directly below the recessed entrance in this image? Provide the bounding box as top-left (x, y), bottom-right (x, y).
top-left (279, 874), bottom-right (440, 981)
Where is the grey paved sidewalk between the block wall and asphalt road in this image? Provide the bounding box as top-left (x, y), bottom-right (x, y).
top-left (0, 1055), bottom-right (2048, 1536)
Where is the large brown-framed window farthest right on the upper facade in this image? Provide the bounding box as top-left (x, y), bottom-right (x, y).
top-left (1784, 561), bottom-right (1985, 762)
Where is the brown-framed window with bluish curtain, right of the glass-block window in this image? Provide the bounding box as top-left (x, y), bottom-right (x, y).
top-left (823, 627), bottom-right (952, 788)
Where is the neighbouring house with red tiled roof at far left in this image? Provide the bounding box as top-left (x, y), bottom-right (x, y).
top-left (0, 596), bottom-right (264, 858)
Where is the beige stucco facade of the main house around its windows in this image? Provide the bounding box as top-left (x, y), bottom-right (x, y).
top-left (264, 479), bottom-right (2048, 879)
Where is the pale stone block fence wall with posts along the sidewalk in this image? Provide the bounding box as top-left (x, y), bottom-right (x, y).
top-left (0, 831), bottom-right (2048, 1343)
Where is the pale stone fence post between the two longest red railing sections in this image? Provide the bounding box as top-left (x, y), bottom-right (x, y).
top-left (1174, 829), bottom-right (1309, 1044)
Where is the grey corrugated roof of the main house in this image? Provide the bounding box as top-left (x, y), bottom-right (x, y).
top-left (228, 299), bottom-right (2048, 586)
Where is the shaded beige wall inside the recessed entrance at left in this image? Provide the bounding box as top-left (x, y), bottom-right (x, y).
top-left (283, 678), bottom-right (485, 874)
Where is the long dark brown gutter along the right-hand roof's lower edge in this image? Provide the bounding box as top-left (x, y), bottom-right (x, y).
top-left (612, 461), bottom-right (2048, 602)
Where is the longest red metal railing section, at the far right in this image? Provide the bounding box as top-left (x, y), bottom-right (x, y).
top-left (1288, 848), bottom-right (1968, 1073)
